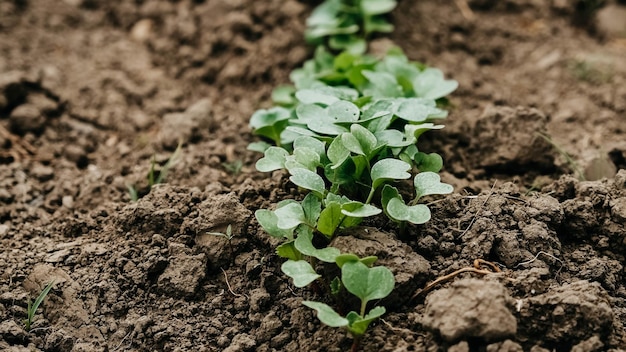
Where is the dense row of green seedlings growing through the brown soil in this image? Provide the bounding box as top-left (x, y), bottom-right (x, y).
top-left (249, 0), bottom-right (457, 343)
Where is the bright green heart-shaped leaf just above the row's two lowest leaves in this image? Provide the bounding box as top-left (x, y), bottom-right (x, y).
top-left (341, 261), bottom-right (395, 305)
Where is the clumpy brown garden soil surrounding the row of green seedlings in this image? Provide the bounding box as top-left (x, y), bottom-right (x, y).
top-left (0, 0), bottom-right (626, 352)
